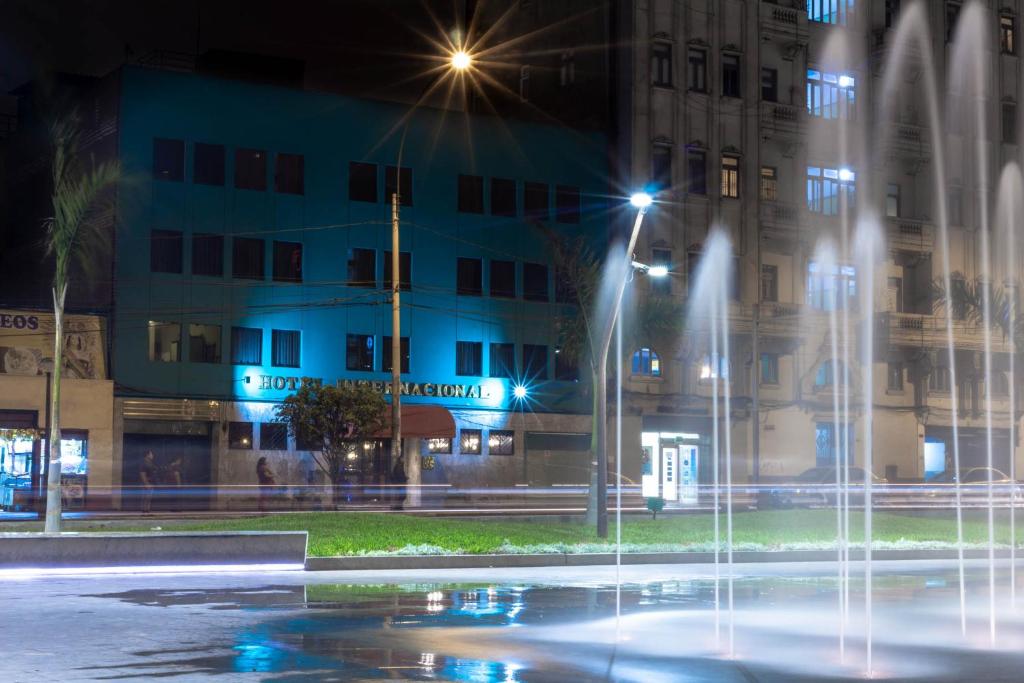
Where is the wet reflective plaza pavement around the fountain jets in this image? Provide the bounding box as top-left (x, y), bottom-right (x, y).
top-left (6, 562), bottom-right (1024, 683)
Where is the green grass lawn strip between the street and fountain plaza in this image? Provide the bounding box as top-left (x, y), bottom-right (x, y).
top-left (0, 510), bottom-right (1024, 556)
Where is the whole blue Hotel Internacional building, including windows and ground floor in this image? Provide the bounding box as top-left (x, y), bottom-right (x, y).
top-left (111, 68), bottom-right (609, 507)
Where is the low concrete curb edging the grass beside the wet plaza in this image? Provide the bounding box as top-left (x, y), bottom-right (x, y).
top-left (306, 549), bottom-right (1010, 571)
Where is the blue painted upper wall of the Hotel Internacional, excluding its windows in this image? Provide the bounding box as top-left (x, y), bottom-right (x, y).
top-left (113, 68), bottom-right (608, 413)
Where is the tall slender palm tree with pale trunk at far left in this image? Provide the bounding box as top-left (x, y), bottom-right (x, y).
top-left (44, 113), bottom-right (121, 532)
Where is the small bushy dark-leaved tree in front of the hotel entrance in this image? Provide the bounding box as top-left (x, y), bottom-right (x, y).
top-left (276, 381), bottom-right (387, 505)
